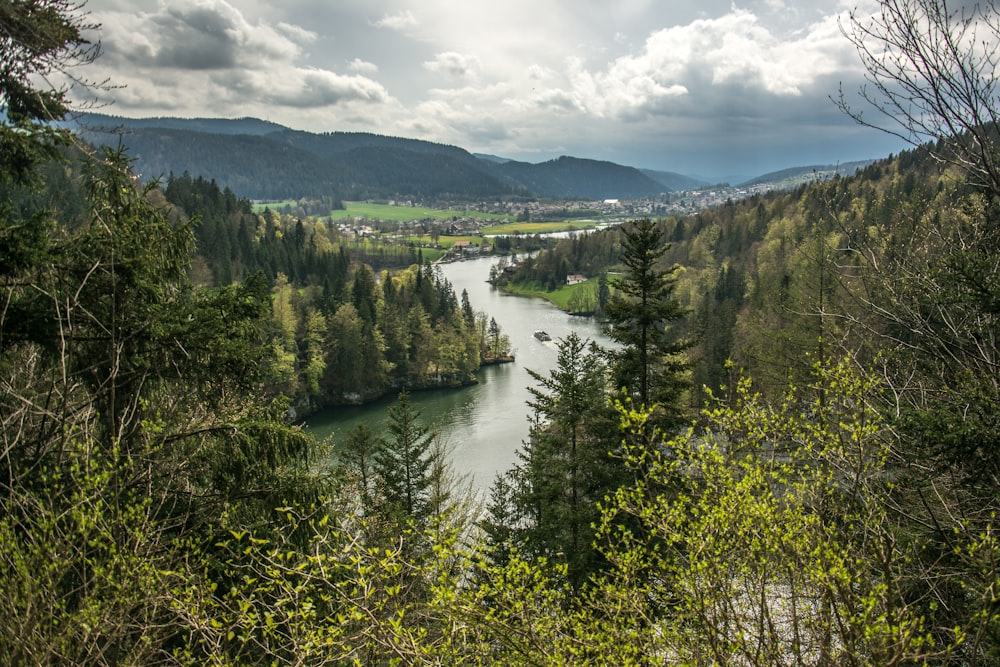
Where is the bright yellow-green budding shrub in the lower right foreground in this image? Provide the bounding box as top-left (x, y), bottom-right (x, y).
top-left (600, 365), bottom-right (963, 665)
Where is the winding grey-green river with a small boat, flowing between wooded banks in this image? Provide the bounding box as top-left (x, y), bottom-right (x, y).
top-left (306, 257), bottom-right (609, 491)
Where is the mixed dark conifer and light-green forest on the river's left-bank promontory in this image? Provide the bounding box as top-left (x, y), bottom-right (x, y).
top-left (162, 174), bottom-right (510, 415)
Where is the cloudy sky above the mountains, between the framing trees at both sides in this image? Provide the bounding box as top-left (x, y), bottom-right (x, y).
top-left (76, 0), bottom-right (901, 178)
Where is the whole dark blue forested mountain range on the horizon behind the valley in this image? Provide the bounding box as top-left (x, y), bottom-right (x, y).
top-left (70, 114), bottom-right (669, 199)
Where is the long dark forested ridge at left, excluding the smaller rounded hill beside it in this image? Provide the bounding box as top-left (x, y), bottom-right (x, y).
top-left (80, 115), bottom-right (524, 199)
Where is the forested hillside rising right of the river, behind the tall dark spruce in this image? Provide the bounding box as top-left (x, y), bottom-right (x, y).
top-left (493, 155), bottom-right (948, 406)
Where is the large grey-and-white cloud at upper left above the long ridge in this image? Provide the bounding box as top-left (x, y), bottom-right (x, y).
top-left (88, 0), bottom-right (392, 115)
